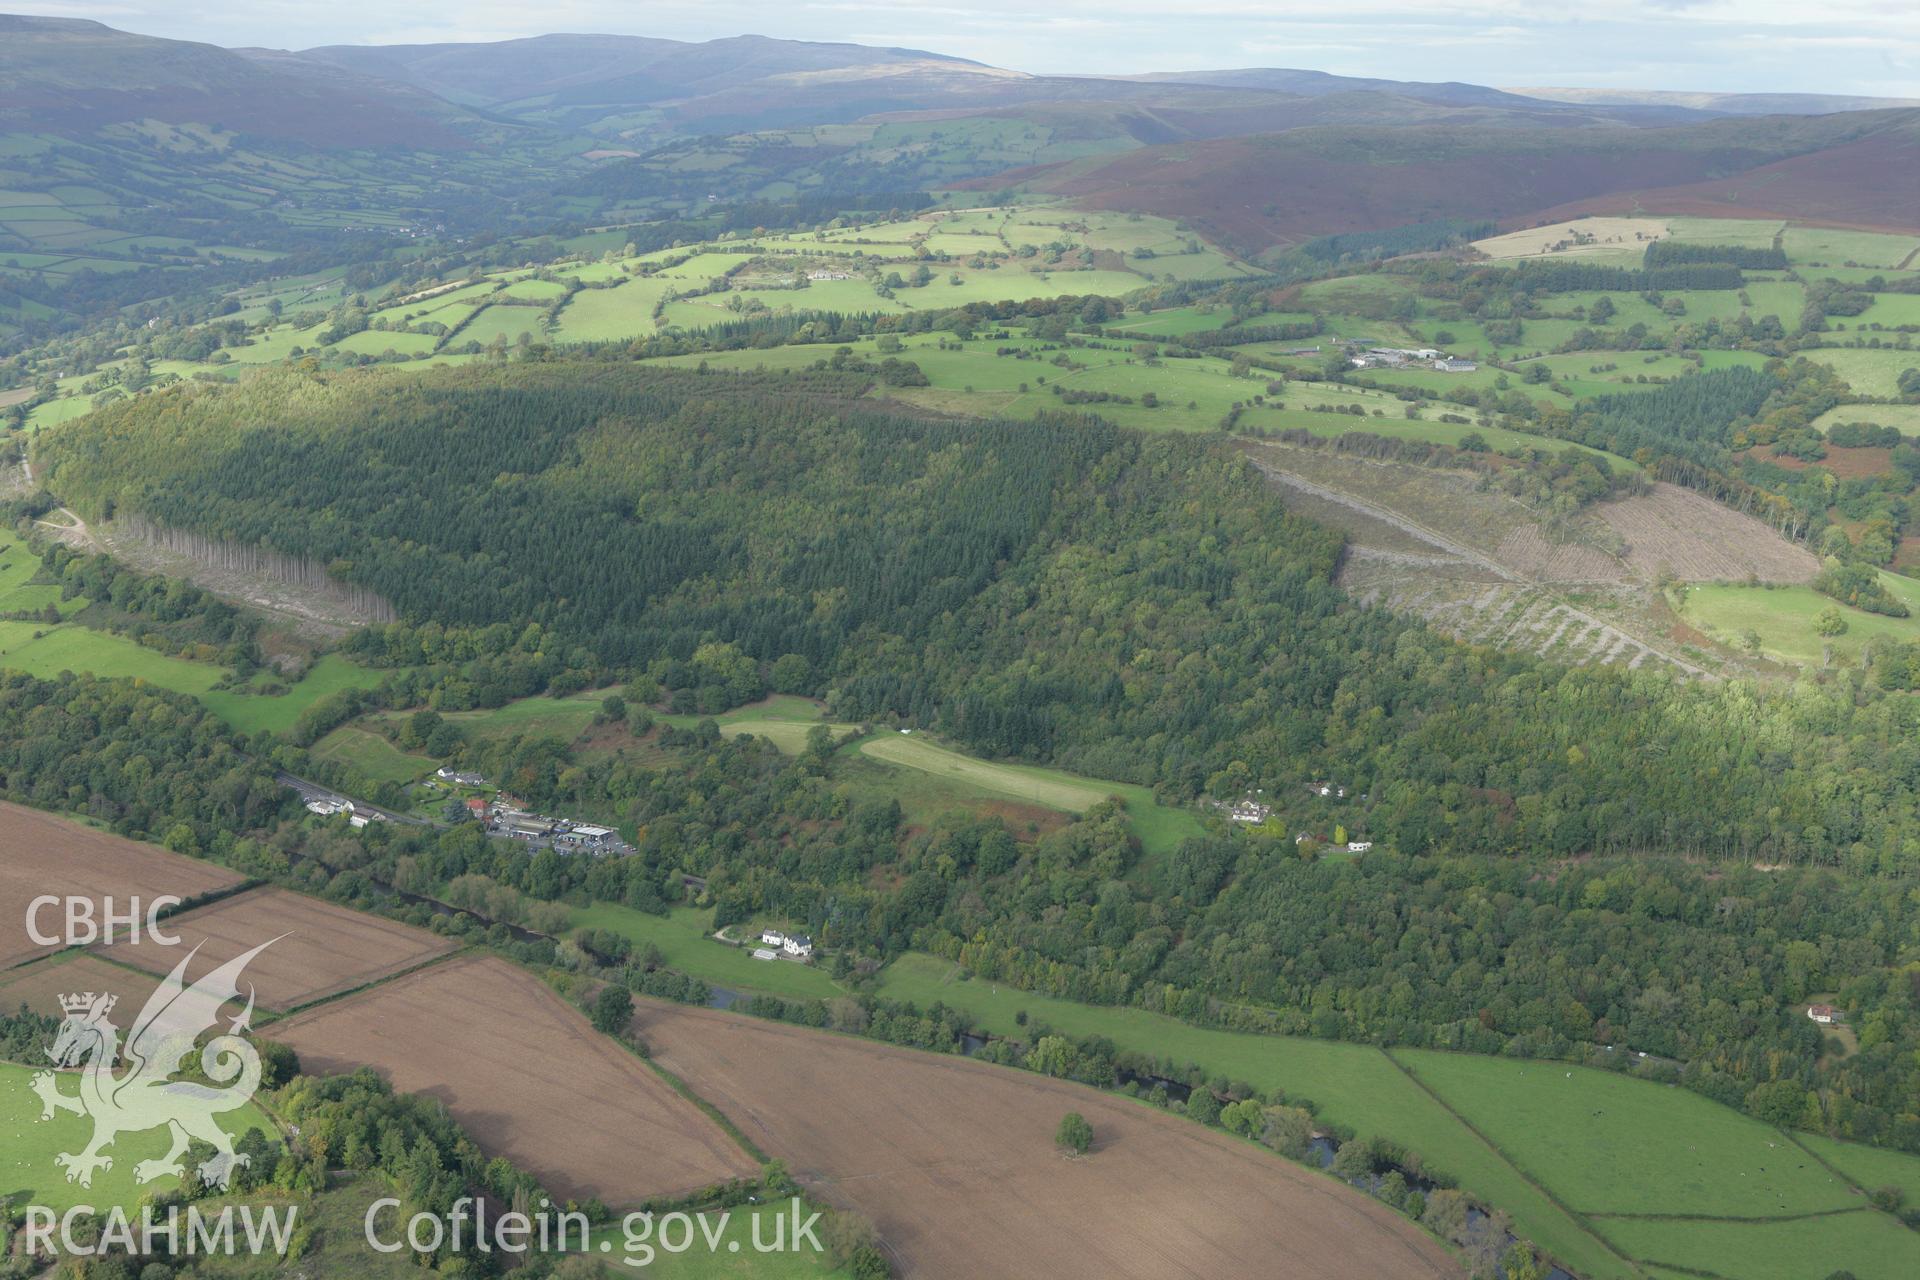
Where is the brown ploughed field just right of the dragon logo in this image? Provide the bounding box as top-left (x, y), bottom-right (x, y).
top-left (269, 956), bottom-right (758, 1207)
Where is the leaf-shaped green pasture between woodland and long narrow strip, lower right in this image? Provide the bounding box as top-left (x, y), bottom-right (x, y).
top-left (1392, 1050), bottom-right (1858, 1220)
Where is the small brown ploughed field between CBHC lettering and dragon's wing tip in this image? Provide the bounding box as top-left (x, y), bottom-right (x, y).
top-left (104, 889), bottom-right (459, 1009)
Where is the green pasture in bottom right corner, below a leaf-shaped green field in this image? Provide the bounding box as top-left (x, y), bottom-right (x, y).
top-left (1599, 1209), bottom-right (1920, 1280)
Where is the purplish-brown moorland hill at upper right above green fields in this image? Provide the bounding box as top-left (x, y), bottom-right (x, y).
top-left (970, 109), bottom-right (1920, 251)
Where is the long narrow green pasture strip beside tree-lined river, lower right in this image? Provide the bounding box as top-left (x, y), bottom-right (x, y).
top-left (879, 952), bottom-right (1632, 1280)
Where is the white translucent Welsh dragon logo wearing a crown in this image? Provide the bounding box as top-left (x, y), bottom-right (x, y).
top-left (33, 938), bottom-right (278, 1192)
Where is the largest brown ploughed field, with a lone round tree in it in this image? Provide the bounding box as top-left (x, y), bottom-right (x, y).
top-left (634, 1000), bottom-right (1459, 1280)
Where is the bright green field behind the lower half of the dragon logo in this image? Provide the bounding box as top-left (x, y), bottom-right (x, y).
top-left (0, 1059), bottom-right (278, 1213)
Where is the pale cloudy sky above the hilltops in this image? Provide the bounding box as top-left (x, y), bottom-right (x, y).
top-left (21, 0), bottom-right (1920, 98)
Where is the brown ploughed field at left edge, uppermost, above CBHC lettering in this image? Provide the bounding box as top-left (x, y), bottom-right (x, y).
top-left (0, 802), bottom-right (240, 969)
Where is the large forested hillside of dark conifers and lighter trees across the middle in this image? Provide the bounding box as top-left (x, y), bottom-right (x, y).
top-left (40, 365), bottom-right (1920, 871)
